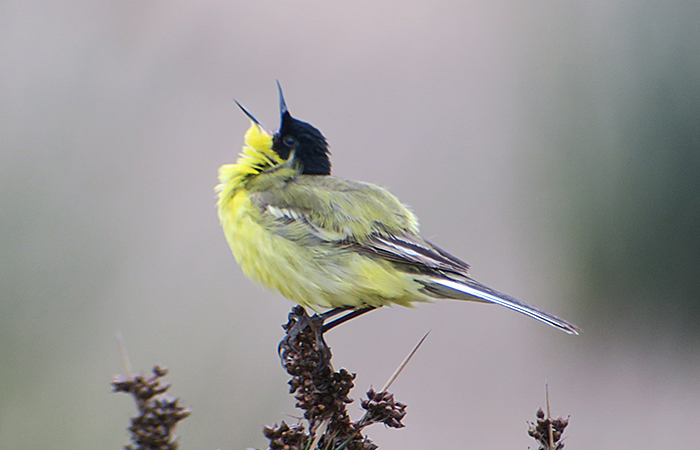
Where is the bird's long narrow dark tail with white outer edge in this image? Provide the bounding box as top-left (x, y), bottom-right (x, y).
top-left (420, 276), bottom-right (580, 335)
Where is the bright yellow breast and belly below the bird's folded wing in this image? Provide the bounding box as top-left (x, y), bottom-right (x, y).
top-left (220, 191), bottom-right (429, 309)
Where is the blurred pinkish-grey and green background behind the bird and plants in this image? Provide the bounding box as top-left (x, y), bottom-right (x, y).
top-left (0, 0), bottom-right (700, 450)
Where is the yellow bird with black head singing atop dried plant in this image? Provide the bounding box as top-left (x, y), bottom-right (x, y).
top-left (216, 81), bottom-right (579, 335)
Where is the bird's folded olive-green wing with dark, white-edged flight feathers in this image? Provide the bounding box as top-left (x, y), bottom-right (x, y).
top-left (253, 177), bottom-right (469, 275)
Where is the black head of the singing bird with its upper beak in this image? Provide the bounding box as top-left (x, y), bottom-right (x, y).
top-left (272, 82), bottom-right (331, 175)
